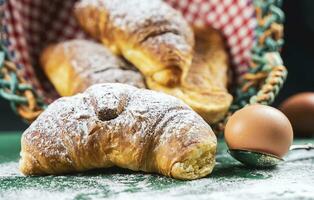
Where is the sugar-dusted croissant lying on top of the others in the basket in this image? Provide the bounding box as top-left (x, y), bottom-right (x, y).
top-left (75, 0), bottom-right (194, 86)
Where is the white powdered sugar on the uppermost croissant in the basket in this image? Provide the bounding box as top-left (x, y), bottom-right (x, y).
top-left (78, 0), bottom-right (187, 32)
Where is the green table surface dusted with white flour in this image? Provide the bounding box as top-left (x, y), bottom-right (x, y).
top-left (0, 133), bottom-right (314, 200)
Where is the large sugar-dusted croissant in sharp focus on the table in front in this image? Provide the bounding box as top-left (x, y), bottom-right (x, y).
top-left (20, 83), bottom-right (217, 179)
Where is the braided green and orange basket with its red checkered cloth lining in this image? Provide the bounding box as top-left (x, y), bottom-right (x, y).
top-left (0, 0), bottom-right (287, 129)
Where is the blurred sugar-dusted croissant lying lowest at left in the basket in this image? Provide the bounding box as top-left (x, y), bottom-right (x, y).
top-left (40, 39), bottom-right (145, 96)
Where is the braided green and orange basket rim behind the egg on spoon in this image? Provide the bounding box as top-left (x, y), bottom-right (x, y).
top-left (213, 0), bottom-right (288, 132)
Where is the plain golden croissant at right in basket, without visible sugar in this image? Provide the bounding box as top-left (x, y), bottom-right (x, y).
top-left (147, 27), bottom-right (232, 123)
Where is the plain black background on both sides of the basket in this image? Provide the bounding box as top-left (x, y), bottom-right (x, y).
top-left (0, 0), bottom-right (314, 131)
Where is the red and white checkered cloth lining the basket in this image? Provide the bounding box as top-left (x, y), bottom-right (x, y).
top-left (4, 0), bottom-right (256, 100)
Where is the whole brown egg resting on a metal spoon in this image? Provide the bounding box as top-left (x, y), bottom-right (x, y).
top-left (225, 105), bottom-right (293, 157)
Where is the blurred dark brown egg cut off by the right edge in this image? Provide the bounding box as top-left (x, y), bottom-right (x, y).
top-left (280, 92), bottom-right (314, 136)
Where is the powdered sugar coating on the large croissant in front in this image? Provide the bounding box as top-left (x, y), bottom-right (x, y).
top-left (22, 83), bottom-right (215, 171)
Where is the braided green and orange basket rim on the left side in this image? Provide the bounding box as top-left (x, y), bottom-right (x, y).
top-left (0, 0), bottom-right (45, 122)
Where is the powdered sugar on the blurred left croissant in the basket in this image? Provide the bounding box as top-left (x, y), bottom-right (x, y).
top-left (55, 39), bottom-right (145, 88)
